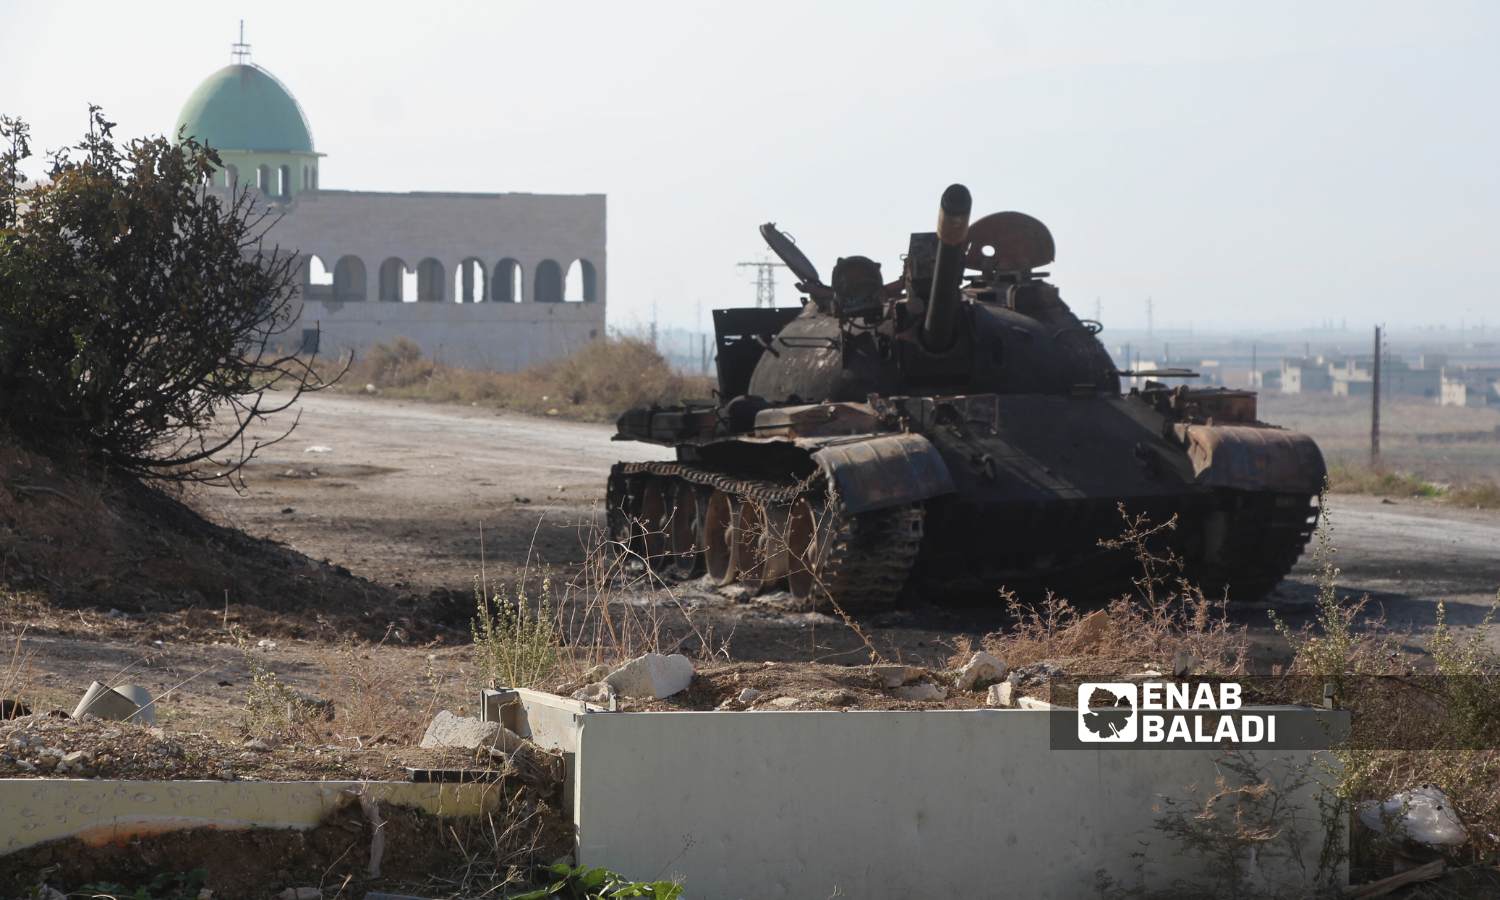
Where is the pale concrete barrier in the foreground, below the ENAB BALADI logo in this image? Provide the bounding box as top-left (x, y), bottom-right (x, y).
top-left (486, 692), bottom-right (1350, 900)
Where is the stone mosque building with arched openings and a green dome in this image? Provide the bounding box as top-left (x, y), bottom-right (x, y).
top-left (176, 27), bottom-right (606, 371)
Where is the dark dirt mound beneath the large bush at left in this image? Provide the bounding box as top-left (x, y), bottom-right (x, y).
top-left (0, 438), bottom-right (435, 639)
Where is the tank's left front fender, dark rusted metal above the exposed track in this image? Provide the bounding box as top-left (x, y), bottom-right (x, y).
top-left (813, 434), bottom-right (956, 513)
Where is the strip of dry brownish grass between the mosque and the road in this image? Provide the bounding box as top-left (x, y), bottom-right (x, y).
top-left (330, 338), bottom-right (713, 422)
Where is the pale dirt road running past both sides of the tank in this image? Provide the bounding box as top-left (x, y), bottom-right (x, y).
top-left (200, 395), bottom-right (1500, 657)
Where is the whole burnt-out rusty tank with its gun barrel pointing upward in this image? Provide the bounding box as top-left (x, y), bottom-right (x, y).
top-left (608, 185), bottom-right (1325, 614)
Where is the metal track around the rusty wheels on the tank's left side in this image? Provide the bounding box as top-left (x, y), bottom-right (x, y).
top-left (609, 462), bottom-right (924, 614)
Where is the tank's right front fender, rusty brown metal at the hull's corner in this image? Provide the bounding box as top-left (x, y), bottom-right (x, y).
top-left (1178, 425), bottom-right (1328, 494)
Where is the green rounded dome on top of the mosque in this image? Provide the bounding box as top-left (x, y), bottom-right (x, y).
top-left (177, 63), bottom-right (314, 153)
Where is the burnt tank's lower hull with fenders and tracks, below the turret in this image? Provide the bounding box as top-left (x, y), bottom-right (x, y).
top-left (611, 395), bottom-right (1325, 611)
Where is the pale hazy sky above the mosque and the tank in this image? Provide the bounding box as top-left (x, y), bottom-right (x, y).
top-left (0, 0), bottom-right (1500, 329)
